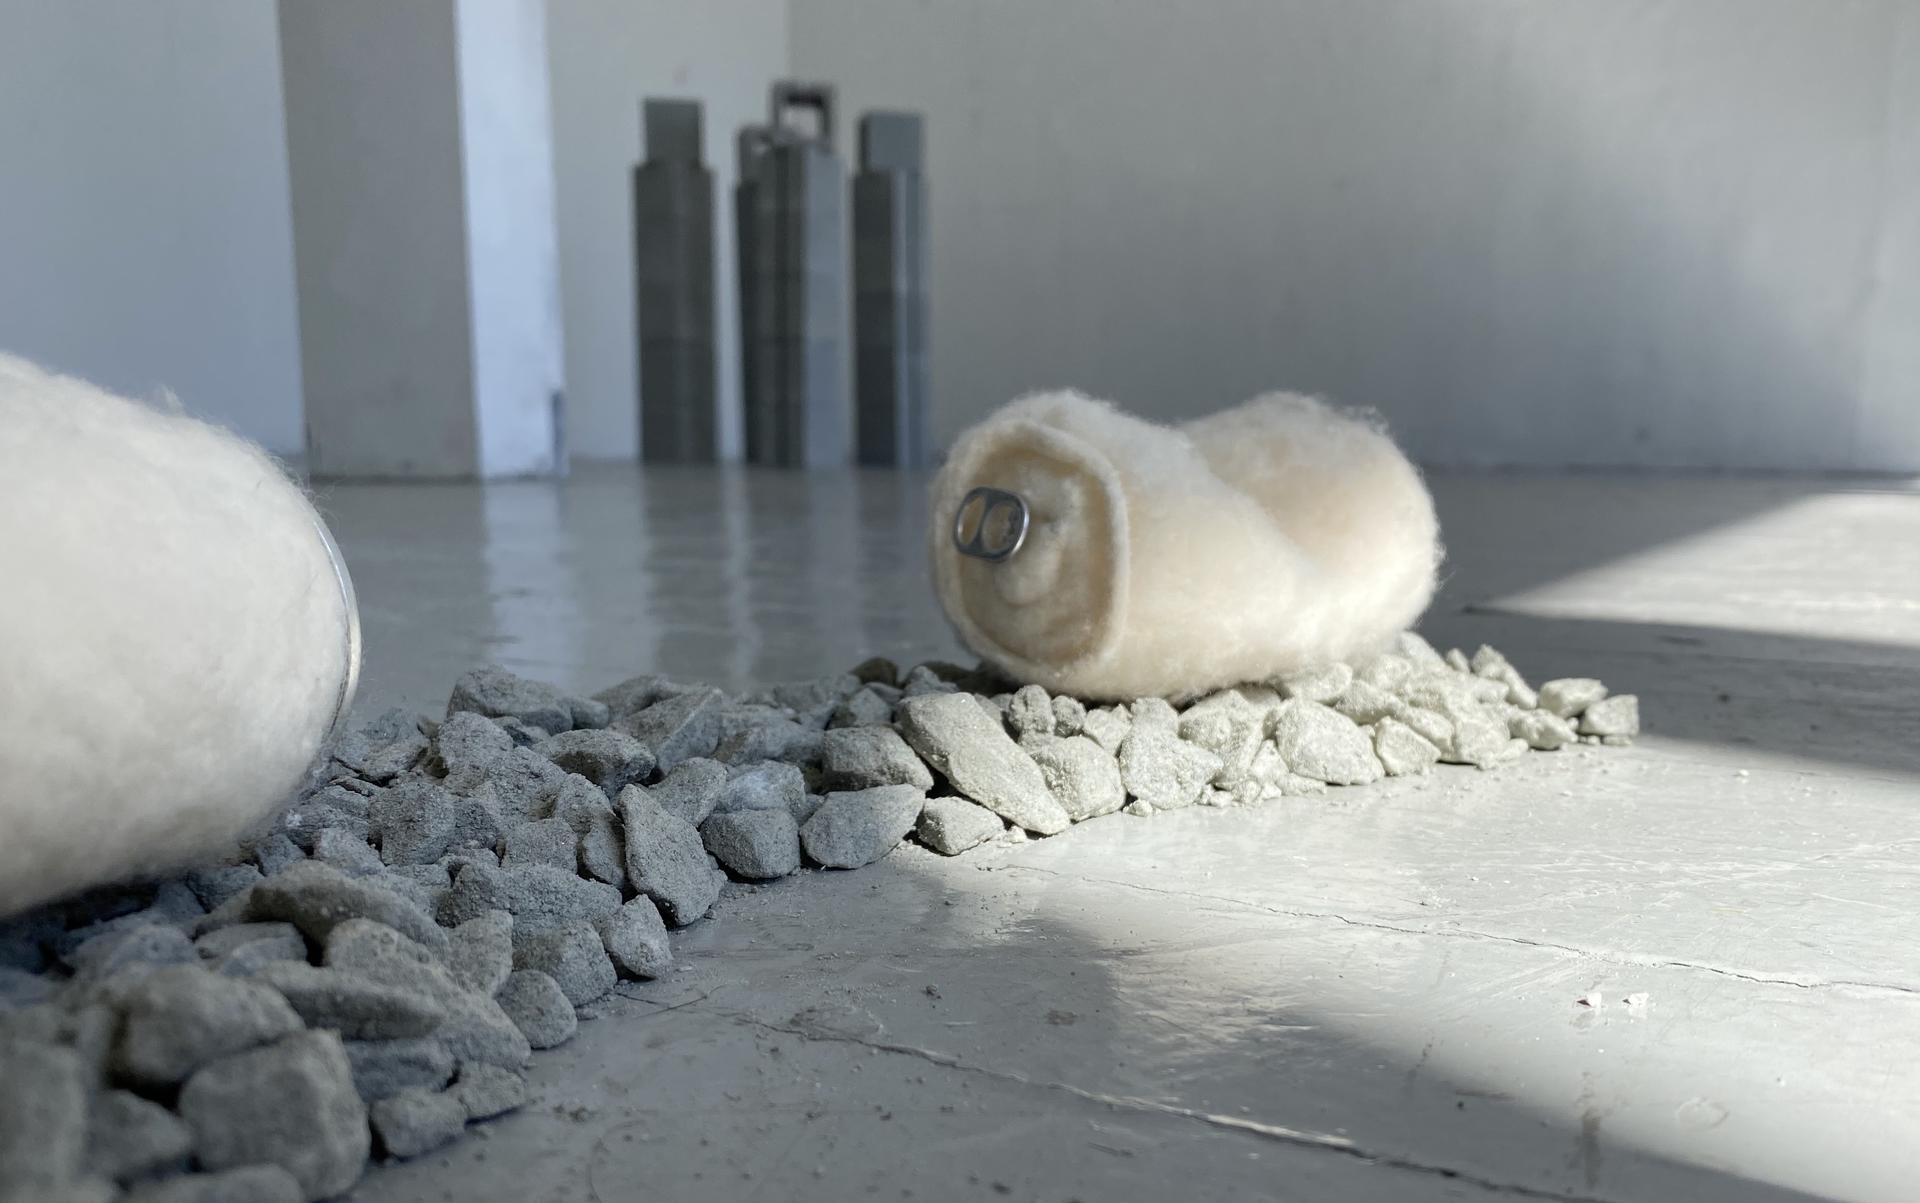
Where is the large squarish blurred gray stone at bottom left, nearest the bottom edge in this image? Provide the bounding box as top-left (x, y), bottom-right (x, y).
top-left (180, 1032), bottom-right (369, 1199)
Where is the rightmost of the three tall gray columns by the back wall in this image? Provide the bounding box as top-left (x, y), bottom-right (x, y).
top-left (852, 113), bottom-right (927, 468)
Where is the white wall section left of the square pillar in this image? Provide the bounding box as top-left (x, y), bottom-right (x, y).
top-left (0, 0), bottom-right (301, 455)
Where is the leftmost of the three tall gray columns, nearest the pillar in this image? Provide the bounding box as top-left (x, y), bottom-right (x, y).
top-left (634, 100), bottom-right (718, 464)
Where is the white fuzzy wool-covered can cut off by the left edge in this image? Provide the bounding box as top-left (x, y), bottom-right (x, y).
top-left (0, 355), bottom-right (359, 915)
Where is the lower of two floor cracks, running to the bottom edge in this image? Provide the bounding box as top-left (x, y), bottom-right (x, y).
top-left (712, 1011), bottom-right (1609, 1203)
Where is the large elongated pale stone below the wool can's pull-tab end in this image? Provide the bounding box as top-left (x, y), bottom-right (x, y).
top-left (894, 695), bottom-right (1071, 832)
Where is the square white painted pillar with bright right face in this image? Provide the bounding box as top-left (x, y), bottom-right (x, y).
top-left (280, 0), bottom-right (564, 478)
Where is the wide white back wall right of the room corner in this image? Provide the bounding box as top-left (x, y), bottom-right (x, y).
top-left (791, 0), bottom-right (1920, 470)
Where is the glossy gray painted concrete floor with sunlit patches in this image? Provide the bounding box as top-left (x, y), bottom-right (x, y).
top-left (324, 470), bottom-right (1920, 1203)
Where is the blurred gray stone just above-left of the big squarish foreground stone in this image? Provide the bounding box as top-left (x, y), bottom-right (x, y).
top-left (111, 965), bottom-right (300, 1086)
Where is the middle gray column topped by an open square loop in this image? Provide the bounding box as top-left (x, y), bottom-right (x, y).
top-left (733, 81), bottom-right (852, 468)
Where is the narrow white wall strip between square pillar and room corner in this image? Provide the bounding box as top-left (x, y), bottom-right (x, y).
top-left (547, 0), bottom-right (789, 459)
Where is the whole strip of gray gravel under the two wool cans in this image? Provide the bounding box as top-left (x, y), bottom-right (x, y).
top-left (0, 635), bottom-right (1640, 1203)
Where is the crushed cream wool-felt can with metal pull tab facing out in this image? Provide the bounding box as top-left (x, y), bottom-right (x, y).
top-left (931, 391), bottom-right (1440, 700)
